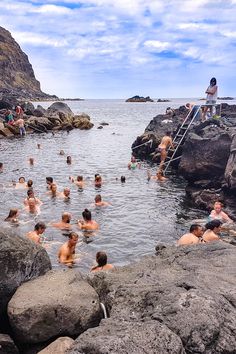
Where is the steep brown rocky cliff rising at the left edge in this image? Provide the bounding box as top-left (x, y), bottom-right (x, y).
top-left (0, 27), bottom-right (55, 99)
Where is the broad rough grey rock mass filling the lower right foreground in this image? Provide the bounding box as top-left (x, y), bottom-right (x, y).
top-left (68, 242), bottom-right (236, 354)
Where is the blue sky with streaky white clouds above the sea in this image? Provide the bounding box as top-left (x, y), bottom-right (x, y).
top-left (0, 0), bottom-right (236, 98)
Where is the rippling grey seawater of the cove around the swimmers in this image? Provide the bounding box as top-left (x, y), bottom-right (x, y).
top-left (0, 100), bottom-right (208, 271)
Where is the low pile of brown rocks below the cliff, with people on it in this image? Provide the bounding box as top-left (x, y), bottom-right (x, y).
top-left (0, 102), bottom-right (94, 139)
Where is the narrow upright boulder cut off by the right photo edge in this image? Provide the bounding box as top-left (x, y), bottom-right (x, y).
top-left (225, 135), bottom-right (236, 192)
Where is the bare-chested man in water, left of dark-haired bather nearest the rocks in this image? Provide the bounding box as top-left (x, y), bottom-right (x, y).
top-left (58, 232), bottom-right (79, 267)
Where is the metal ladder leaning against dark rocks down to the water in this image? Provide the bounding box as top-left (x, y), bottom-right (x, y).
top-left (163, 105), bottom-right (201, 175)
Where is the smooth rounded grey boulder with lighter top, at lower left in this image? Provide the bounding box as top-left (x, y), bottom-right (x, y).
top-left (8, 269), bottom-right (101, 343)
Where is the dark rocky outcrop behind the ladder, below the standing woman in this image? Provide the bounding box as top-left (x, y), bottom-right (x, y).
top-left (132, 103), bottom-right (236, 217)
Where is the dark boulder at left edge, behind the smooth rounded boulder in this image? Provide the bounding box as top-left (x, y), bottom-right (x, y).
top-left (0, 230), bottom-right (51, 328)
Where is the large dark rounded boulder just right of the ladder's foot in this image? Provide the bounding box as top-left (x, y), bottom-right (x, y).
top-left (179, 125), bottom-right (232, 183)
